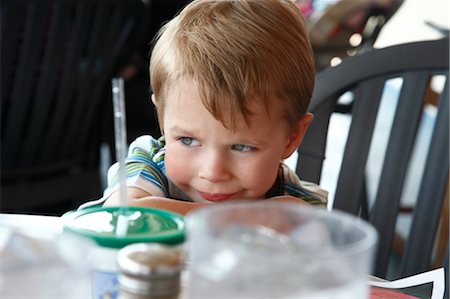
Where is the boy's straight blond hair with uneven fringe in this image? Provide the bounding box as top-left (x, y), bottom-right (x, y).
top-left (150, 0), bottom-right (315, 129)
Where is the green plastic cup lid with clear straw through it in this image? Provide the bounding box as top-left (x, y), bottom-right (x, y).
top-left (62, 207), bottom-right (185, 248)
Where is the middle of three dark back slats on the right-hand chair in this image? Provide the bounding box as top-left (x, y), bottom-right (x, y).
top-left (370, 72), bottom-right (429, 276)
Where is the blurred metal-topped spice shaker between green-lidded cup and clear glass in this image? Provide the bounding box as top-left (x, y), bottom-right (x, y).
top-left (117, 243), bottom-right (183, 299)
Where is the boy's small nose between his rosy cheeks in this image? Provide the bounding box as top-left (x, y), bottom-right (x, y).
top-left (199, 153), bottom-right (230, 183)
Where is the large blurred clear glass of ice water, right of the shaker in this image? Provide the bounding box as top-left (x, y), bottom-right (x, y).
top-left (186, 202), bottom-right (377, 298)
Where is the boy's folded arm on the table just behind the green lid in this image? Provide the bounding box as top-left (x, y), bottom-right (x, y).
top-left (104, 187), bottom-right (205, 215)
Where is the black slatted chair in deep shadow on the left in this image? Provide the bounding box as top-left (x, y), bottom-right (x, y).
top-left (0, 0), bottom-right (148, 214)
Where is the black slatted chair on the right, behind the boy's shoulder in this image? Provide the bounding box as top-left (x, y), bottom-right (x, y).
top-left (296, 38), bottom-right (449, 279)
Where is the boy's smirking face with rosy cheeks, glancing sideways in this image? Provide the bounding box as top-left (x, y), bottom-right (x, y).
top-left (158, 80), bottom-right (307, 202)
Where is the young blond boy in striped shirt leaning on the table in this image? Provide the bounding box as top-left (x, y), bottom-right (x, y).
top-left (82, 0), bottom-right (326, 214)
